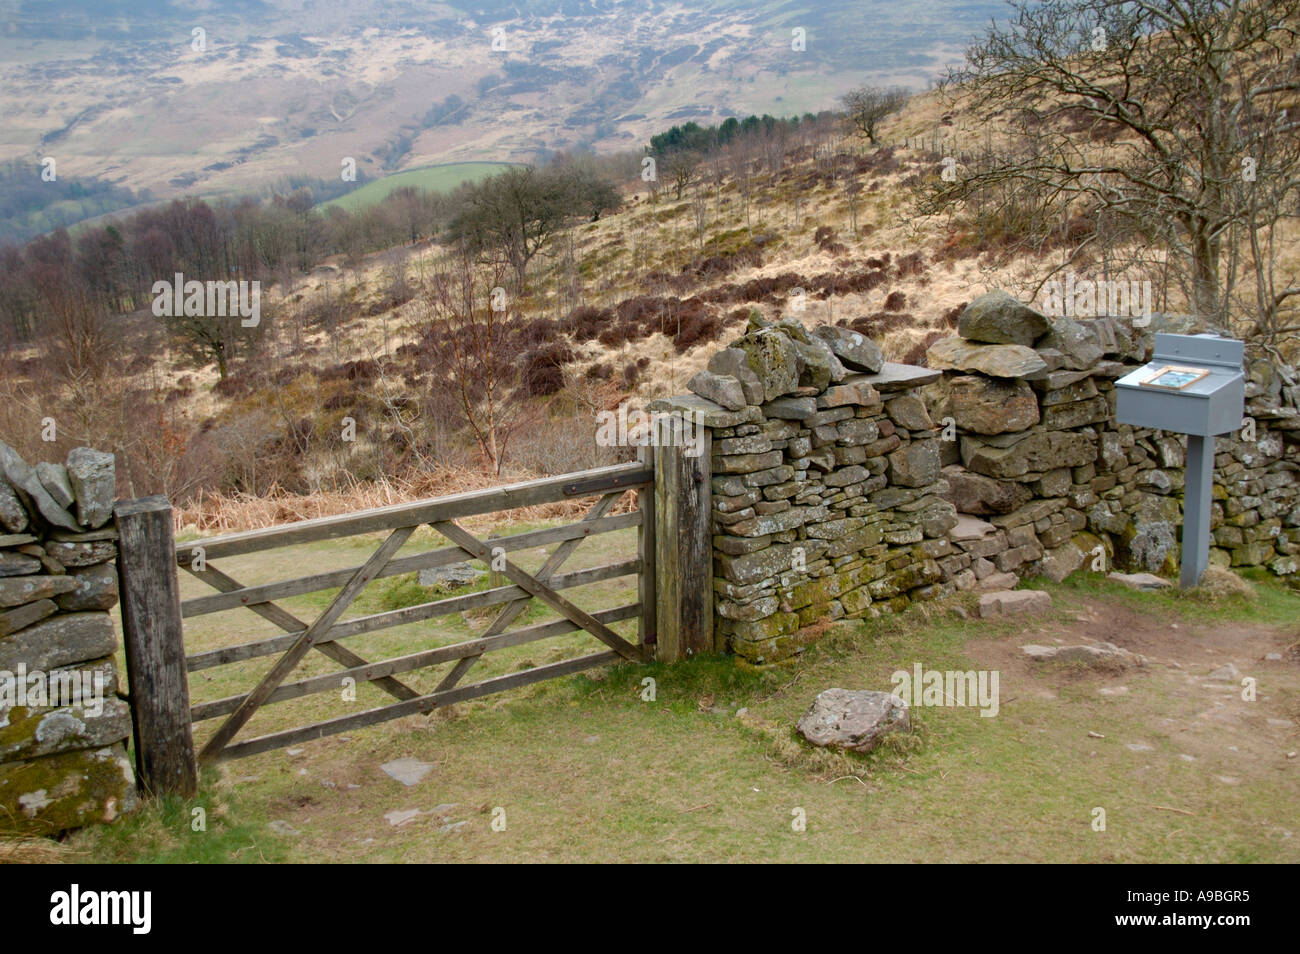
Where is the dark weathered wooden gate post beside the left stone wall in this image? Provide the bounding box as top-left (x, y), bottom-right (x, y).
top-left (113, 496), bottom-right (199, 797)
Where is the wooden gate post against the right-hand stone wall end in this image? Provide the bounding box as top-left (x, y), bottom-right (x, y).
top-left (654, 413), bottom-right (714, 663)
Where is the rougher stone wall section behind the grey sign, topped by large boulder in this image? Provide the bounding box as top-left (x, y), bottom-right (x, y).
top-left (928, 292), bottom-right (1300, 589)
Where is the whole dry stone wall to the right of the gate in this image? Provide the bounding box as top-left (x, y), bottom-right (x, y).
top-left (650, 292), bottom-right (1300, 665)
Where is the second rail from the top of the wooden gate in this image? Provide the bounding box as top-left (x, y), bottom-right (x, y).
top-left (181, 511), bottom-right (641, 619)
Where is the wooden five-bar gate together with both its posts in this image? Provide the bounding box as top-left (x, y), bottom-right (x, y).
top-left (116, 446), bottom-right (714, 793)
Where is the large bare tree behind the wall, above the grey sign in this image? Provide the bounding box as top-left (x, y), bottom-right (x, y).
top-left (922, 0), bottom-right (1300, 331)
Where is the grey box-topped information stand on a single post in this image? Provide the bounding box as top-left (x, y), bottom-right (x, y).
top-left (1115, 334), bottom-right (1245, 587)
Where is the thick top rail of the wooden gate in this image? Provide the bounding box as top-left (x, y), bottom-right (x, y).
top-left (176, 463), bottom-right (654, 563)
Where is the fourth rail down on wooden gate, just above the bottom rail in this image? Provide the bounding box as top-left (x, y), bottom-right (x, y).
top-left (190, 603), bottom-right (641, 723)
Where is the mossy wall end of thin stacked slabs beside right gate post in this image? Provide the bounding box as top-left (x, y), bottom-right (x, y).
top-left (650, 318), bottom-right (957, 665)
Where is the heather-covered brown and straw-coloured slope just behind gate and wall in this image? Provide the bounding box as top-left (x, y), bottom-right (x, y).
top-left (5, 94), bottom-right (1066, 522)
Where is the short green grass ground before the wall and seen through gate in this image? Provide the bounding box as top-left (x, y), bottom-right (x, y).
top-left (78, 538), bottom-right (1300, 863)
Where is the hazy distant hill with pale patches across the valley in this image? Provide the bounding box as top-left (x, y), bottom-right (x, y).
top-left (0, 0), bottom-right (1005, 233)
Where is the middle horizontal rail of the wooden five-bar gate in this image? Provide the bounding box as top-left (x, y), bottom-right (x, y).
top-left (186, 560), bottom-right (641, 672)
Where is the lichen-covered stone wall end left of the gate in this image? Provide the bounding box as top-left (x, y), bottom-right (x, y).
top-left (0, 442), bottom-right (137, 833)
